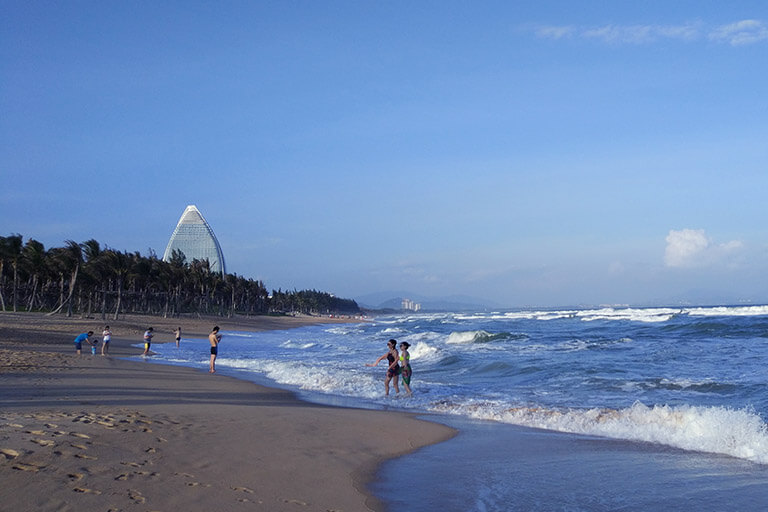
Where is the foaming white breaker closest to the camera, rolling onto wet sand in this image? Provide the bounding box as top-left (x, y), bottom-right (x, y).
top-left (432, 401), bottom-right (768, 464)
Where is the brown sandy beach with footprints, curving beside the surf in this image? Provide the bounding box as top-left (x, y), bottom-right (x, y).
top-left (0, 313), bottom-right (454, 512)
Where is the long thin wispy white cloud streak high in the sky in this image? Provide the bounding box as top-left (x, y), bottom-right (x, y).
top-left (534, 20), bottom-right (768, 46)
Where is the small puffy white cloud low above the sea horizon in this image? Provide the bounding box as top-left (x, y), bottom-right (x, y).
top-left (664, 229), bottom-right (744, 268)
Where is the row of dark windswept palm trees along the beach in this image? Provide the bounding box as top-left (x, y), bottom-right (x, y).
top-left (0, 234), bottom-right (360, 319)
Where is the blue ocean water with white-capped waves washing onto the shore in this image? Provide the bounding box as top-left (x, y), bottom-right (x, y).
top-left (142, 306), bottom-right (768, 511)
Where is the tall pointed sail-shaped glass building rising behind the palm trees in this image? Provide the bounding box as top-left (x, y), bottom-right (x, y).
top-left (163, 204), bottom-right (227, 274)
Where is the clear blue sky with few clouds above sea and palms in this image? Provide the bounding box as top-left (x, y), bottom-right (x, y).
top-left (0, 1), bottom-right (768, 306)
